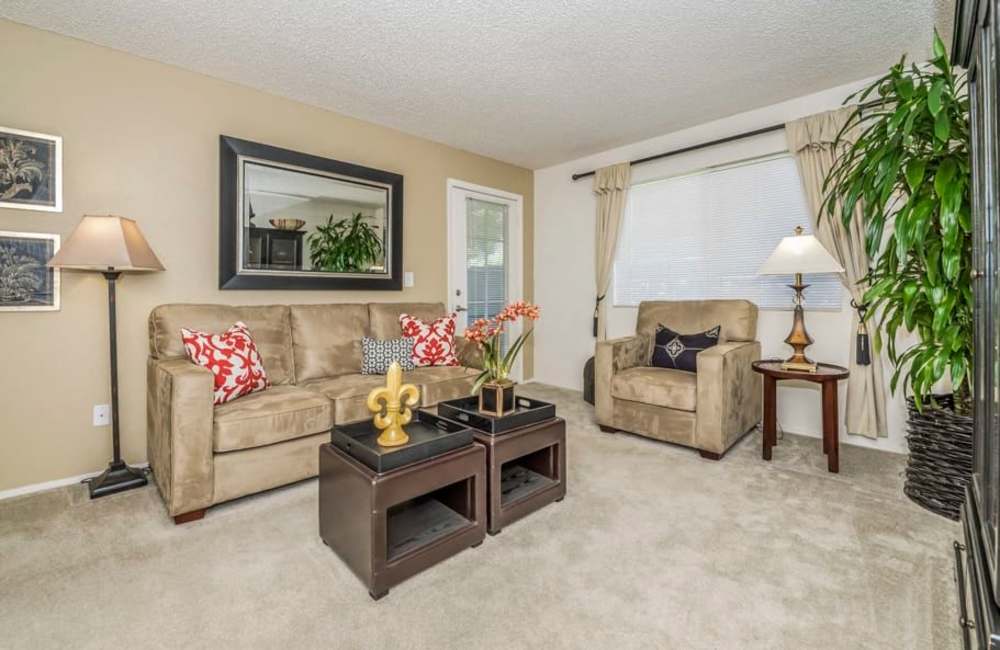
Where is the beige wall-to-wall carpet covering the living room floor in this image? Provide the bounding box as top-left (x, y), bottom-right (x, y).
top-left (0, 385), bottom-right (959, 650)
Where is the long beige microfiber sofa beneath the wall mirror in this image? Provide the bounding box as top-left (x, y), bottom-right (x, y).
top-left (146, 303), bottom-right (481, 523)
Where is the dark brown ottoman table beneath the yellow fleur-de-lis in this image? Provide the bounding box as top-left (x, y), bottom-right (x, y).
top-left (319, 412), bottom-right (487, 600)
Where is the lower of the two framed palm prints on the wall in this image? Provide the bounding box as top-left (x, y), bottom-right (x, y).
top-left (0, 230), bottom-right (59, 311)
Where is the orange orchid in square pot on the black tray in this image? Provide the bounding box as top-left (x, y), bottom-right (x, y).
top-left (465, 300), bottom-right (539, 417)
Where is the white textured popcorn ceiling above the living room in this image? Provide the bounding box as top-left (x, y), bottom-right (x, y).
top-left (0, 0), bottom-right (954, 168)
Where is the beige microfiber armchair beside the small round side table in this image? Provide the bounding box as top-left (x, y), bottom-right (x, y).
top-left (594, 300), bottom-right (762, 460)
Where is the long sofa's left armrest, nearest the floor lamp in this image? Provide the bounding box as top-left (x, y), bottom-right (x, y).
top-left (146, 359), bottom-right (215, 516)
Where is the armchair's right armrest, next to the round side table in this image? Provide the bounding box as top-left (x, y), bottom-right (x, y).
top-left (695, 341), bottom-right (763, 454)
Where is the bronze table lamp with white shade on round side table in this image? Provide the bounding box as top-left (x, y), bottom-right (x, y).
top-left (757, 226), bottom-right (844, 372)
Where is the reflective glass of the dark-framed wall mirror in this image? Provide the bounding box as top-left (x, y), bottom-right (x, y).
top-left (241, 160), bottom-right (391, 275)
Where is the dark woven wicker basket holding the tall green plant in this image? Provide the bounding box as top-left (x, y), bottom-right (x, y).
top-left (903, 395), bottom-right (972, 520)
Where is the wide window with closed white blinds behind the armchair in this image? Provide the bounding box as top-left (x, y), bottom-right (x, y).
top-left (614, 154), bottom-right (842, 310)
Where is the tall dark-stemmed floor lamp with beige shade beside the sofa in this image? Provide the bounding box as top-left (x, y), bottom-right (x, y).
top-left (48, 215), bottom-right (163, 499)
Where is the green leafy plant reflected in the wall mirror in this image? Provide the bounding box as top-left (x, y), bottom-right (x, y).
top-left (308, 212), bottom-right (383, 273)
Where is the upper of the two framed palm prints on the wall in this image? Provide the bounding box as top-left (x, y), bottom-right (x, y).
top-left (0, 126), bottom-right (62, 212)
